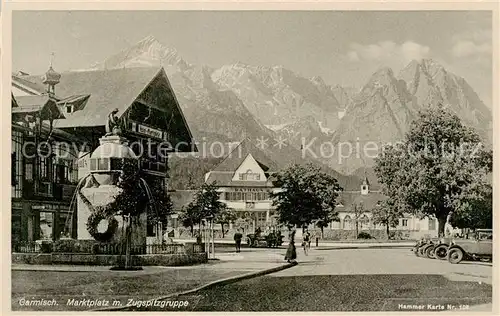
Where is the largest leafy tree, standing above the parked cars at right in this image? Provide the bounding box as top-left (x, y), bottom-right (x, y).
top-left (375, 106), bottom-right (492, 236)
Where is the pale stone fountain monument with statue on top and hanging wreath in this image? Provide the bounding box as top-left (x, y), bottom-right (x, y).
top-left (77, 109), bottom-right (147, 249)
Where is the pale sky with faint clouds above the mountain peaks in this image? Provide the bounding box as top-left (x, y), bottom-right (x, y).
top-left (13, 11), bottom-right (492, 105)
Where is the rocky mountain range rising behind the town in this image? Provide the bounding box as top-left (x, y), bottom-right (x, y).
top-left (90, 36), bottom-right (492, 183)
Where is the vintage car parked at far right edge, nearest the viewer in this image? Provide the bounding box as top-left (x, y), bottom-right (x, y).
top-left (447, 229), bottom-right (493, 264)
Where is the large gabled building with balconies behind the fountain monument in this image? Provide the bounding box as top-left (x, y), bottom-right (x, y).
top-left (12, 67), bottom-right (196, 241)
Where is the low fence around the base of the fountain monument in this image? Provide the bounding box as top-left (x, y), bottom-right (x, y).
top-left (12, 240), bottom-right (205, 255)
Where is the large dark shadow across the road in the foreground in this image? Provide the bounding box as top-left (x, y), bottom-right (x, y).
top-left (163, 275), bottom-right (492, 311)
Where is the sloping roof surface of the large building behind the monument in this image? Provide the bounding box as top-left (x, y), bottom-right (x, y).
top-left (22, 67), bottom-right (161, 128)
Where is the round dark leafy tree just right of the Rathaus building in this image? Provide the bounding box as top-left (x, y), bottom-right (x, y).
top-left (271, 164), bottom-right (342, 227)
